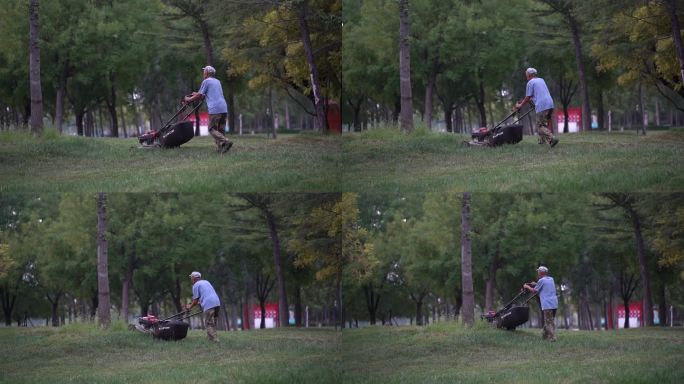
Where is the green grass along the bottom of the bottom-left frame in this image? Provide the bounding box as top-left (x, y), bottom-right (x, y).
top-left (0, 325), bottom-right (340, 383)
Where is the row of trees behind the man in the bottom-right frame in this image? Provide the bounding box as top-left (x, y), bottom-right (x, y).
top-left (346, 193), bottom-right (684, 329)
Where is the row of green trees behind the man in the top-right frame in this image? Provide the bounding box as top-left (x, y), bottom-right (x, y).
top-left (342, 0), bottom-right (684, 132)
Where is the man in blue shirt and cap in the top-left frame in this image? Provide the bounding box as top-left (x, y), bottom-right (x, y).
top-left (183, 65), bottom-right (233, 154)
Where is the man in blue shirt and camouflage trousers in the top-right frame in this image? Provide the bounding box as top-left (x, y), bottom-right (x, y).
top-left (513, 68), bottom-right (558, 148)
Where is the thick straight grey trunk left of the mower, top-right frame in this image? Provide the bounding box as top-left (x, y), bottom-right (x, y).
top-left (399, 0), bottom-right (413, 133)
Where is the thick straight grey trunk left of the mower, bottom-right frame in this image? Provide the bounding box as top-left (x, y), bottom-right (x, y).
top-left (461, 192), bottom-right (475, 325)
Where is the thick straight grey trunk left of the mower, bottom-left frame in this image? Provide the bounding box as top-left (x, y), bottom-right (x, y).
top-left (97, 192), bottom-right (112, 328)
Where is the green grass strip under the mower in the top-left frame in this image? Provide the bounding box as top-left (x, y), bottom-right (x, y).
top-left (0, 133), bottom-right (340, 192)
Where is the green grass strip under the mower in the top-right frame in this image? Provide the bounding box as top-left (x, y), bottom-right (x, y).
top-left (341, 128), bottom-right (684, 192)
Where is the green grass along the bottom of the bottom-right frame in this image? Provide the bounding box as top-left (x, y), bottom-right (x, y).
top-left (342, 324), bottom-right (684, 384)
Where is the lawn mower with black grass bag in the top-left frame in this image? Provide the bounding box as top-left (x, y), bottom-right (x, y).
top-left (138, 96), bottom-right (202, 148)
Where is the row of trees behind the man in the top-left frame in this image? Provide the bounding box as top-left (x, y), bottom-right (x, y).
top-left (0, 0), bottom-right (342, 137)
